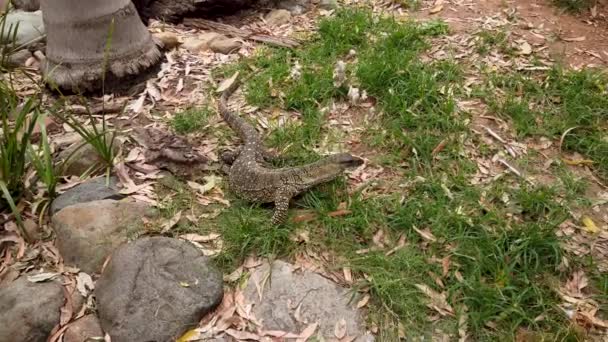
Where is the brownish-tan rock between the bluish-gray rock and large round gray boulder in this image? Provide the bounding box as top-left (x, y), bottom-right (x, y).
top-left (52, 200), bottom-right (153, 273)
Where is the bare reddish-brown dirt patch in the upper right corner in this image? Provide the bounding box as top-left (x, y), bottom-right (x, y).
top-left (416, 0), bottom-right (608, 68)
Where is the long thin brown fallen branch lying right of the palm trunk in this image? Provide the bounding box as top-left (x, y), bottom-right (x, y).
top-left (184, 18), bottom-right (300, 48)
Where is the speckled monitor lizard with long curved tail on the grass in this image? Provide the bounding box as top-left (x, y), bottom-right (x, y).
top-left (219, 82), bottom-right (363, 224)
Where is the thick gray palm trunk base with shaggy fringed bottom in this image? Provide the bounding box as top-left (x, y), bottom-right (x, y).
top-left (41, 0), bottom-right (161, 91)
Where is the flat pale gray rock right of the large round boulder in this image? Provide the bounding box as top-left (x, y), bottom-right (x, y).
top-left (244, 261), bottom-right (373, 342)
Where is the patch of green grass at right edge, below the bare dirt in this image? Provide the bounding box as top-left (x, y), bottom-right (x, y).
top-left (479, 67), bottom-right (608, 179)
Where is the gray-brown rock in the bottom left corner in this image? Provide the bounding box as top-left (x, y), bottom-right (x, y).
top-left (0, 276), bottom-right (64, 342)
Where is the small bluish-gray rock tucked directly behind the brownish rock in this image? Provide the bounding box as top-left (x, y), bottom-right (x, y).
top-left (51, 176), bottom-right (125, 215)
